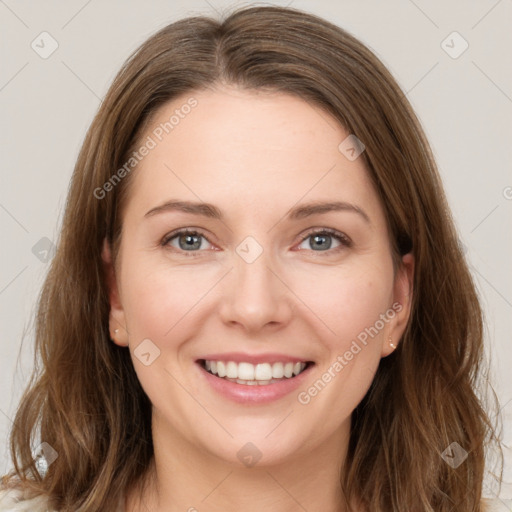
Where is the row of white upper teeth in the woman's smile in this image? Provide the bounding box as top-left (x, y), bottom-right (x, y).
top-left (204, 361), bottom-right (306, 386)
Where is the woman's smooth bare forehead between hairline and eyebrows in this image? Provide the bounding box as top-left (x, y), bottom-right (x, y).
top-left (121, 87), bottom-right (382, 224)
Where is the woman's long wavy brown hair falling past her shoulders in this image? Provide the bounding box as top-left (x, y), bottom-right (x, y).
top-left (1, 7), bottom-right (501, 512)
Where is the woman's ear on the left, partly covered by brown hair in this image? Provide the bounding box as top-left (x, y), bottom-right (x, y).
top-left (101, 238), bottom-right (128, 347)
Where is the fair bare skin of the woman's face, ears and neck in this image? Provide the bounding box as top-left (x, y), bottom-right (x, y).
top-left (103, 86), bottom-right (414, 512)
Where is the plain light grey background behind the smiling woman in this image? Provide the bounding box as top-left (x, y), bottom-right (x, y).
top-left (0, 0), bottom-right (512, 504)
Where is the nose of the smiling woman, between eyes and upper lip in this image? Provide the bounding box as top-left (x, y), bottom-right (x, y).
top-left (220, 245), bottom-right (293, 333)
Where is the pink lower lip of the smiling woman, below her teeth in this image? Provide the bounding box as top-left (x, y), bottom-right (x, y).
top-left (197, 363), bottom-right (314, 404)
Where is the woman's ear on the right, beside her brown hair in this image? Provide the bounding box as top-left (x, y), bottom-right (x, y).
top-left (381, 253), bottom-right (415, 357)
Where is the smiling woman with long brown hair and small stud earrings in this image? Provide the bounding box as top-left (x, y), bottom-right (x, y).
top-left (3, 7), bottom-right (499, 512)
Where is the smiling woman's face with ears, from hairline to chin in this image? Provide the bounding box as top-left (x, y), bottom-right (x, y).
top-left (104, 87), bottom-right (413, 465)
